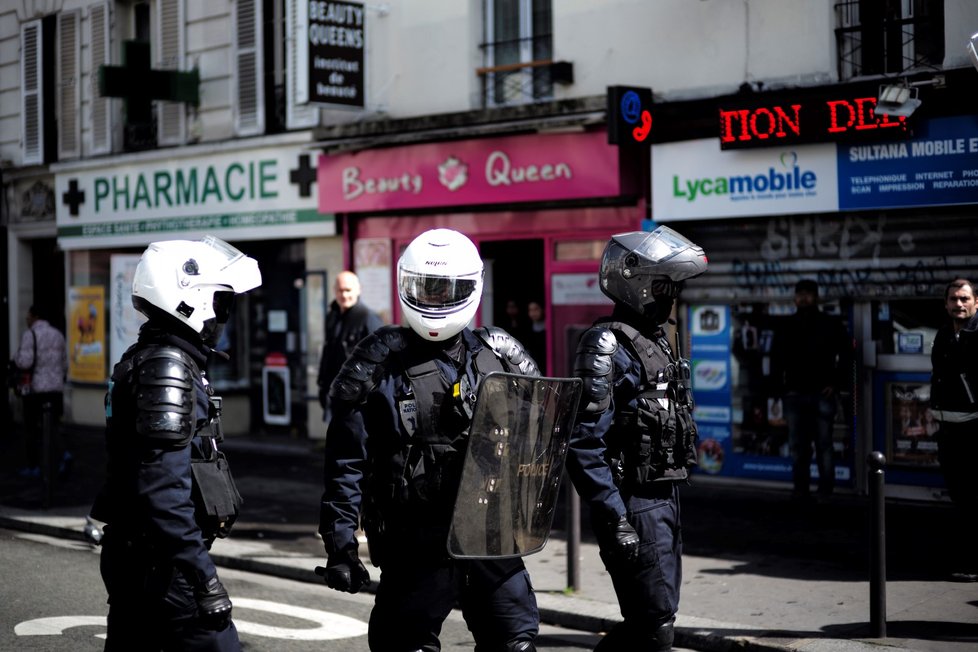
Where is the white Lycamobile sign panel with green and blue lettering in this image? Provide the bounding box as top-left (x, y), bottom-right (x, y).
top-left (652, 139), bottom-right (837, 220)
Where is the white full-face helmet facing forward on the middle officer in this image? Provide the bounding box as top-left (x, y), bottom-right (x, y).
top-left (397, 229), bottom-right (483, 342)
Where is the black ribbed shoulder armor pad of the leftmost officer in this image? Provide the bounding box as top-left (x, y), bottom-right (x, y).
top-left (133, 346), bottom-right (198, 448)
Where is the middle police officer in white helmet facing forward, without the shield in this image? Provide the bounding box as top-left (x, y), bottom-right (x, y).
top-left (317, 229), bottom-right (540, 652)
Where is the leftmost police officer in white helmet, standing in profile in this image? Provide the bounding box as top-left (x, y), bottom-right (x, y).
top-left (91, 236), bottom-right (261, 652)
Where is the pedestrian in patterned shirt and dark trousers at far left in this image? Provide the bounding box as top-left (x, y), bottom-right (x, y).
top-left (14, 304), bottom-right (72, 477)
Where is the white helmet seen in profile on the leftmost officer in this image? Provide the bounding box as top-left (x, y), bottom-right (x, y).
top-left (132, 235), bottom-right (261, 346)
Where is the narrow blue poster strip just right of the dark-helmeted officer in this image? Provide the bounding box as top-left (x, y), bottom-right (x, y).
top-left (689, 305), bottom-right (731, 475)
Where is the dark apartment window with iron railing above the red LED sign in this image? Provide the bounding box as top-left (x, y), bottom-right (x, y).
top-left (835, 0), bottom-right (944, 80)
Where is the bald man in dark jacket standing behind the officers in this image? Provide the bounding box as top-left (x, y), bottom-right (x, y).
top-left (316, 271), bottom-right (384, 423)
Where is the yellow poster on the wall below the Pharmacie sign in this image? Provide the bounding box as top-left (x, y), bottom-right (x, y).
top-left (66, 285), bottom-right (106, 383)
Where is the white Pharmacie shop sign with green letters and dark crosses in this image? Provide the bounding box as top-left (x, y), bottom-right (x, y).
top-left (55, 145), bottom-right (336, 249)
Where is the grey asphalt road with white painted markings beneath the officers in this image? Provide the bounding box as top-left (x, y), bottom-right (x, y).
top-left (0, 530), bottom-right (688, 652)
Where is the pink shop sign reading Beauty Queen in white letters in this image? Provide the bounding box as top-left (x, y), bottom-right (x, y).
top-left (317, 132), bottom-right (620, 213)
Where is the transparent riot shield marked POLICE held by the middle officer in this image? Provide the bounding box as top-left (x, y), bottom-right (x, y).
top-left (448, 372), bottom-right (582, 559)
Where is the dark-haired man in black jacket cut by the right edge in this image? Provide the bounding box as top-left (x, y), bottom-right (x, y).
top-left (930, 278), bottom-right (978, 582)
